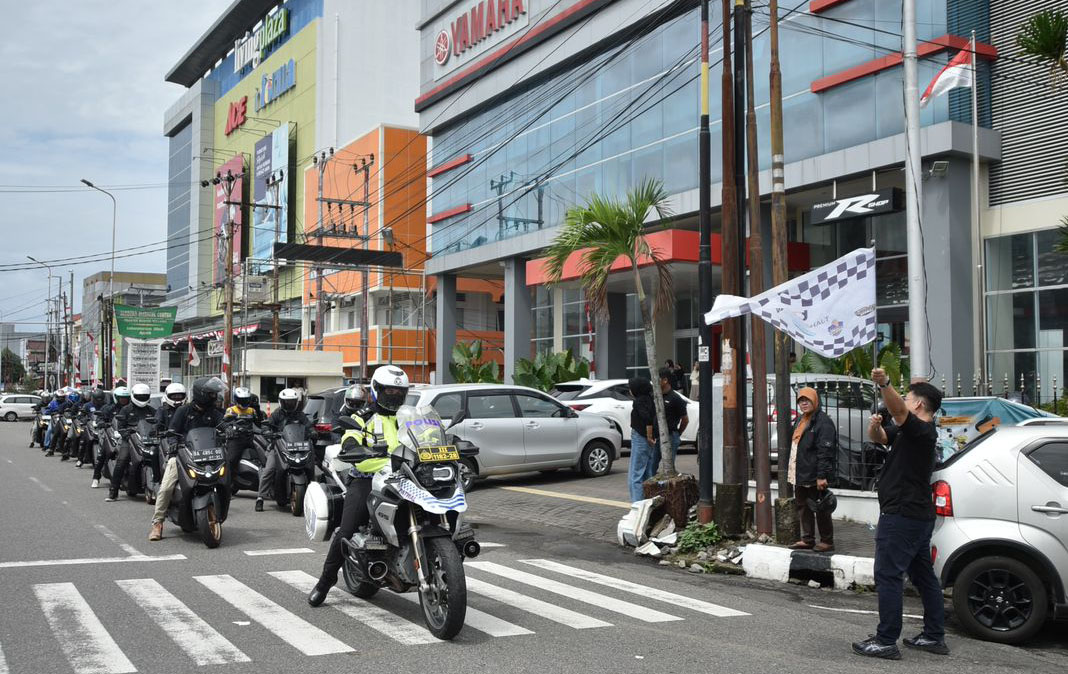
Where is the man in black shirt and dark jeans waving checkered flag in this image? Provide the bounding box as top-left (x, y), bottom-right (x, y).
top-left (853, 367), bottom-right (949, 660)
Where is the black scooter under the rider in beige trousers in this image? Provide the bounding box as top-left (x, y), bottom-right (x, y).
top-left (167, 427), bottom-right (231, 548)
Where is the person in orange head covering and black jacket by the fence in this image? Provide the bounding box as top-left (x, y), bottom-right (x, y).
top-left (786, 387), bottom-right (838, 552)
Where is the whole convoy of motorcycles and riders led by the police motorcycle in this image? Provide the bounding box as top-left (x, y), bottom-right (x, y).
top-left (21, 365), bottom-right (481, 640)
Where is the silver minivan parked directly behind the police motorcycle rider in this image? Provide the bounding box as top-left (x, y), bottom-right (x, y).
top-left (405, 383), bottom-right (622, 487)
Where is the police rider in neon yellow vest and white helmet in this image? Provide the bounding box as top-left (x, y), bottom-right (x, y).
top-left (308, 365), bottom-right (411, 607)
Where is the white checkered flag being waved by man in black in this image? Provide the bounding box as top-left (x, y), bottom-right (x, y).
top-left (705, 248), bottom-right (876, 358)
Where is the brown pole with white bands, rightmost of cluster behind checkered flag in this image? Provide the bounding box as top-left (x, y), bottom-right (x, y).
top-left (768, 0), bottom-right (798, 543)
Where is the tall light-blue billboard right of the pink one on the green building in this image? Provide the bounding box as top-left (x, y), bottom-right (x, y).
top-left (251, 123), bottom-right (289, 270)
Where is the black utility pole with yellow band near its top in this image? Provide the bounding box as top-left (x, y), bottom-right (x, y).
top-left (697, 0), bottom-right (716, 524)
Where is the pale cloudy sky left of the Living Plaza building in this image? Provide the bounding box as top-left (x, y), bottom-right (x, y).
top-left (0, 0), bottom-right (221, 331)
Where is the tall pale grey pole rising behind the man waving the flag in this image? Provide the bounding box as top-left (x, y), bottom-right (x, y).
top-left (901, 0), bottom-right (927, 381)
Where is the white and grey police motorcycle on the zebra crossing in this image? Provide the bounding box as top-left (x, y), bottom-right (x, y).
top-left (320, 405), bottom-right (481, 639)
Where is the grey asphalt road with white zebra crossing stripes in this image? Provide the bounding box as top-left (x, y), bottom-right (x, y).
top-left (0, 423), bottom-right (1068, 674)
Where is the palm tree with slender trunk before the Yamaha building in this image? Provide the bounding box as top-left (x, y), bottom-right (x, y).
top-left (546, 179), bottom-right (677, 476)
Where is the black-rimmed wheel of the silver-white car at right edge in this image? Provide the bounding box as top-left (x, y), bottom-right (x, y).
top-left (953, 557), bottom-right (1049, 644)
